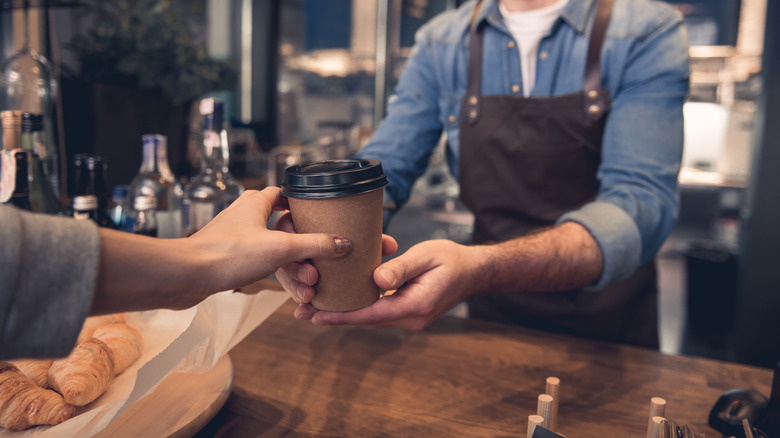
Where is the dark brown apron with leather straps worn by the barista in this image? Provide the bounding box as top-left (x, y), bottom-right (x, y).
top-left (459, 0), bottom-right (658, 348)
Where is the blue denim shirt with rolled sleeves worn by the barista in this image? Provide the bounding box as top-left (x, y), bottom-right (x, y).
top-left (360, 0), bottom-right (689, 289)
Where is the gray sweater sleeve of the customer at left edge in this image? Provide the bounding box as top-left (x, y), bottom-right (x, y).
top-left (0, 205), bottom-right (100, 359)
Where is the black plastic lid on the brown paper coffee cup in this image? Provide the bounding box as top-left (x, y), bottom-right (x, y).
top-left (282, 159), bottom-right (387, 199)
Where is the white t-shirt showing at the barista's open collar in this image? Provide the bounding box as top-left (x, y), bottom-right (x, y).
top-left (498, 0), bottom-right (569, 96)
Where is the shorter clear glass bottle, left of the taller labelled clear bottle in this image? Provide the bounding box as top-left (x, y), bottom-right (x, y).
top-left (130, 134), bottom-right (184, 238)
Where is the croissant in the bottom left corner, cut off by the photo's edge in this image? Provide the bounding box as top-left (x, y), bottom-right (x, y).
top-left (0, 362), bottom-right (76, 431)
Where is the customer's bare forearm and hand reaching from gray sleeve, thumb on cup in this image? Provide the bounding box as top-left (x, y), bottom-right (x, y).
top-left (91, 187), bottom-right (351, 314)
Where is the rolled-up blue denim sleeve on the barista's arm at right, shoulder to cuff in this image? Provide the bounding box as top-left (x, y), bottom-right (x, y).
top-left (558, 7), bottom-right (689, 289)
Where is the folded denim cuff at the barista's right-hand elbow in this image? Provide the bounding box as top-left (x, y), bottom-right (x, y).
top-left (557, 202), bottom-right (642, 290)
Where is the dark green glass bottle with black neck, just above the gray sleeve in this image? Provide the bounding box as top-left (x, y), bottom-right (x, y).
top-left (20, 113), bottom-right (63, 214)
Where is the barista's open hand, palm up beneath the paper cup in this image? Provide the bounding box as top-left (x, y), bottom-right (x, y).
top-left (295, 240), bottom-right (486, 331)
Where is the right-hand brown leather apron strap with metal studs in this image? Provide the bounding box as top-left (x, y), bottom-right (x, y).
top-left (584, 0), bottom-right (614, 120)
